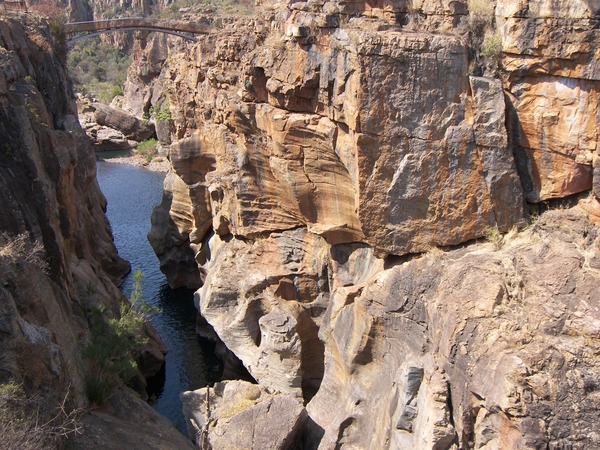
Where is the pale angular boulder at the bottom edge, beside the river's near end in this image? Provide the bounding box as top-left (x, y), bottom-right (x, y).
top-left (181, 381), bottom-right (307, 450)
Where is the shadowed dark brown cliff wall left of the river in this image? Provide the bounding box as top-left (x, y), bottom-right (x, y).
top-left (0, 14), bottom-right (175, 448)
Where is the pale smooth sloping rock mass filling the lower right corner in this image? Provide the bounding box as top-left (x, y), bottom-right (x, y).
top-left (307, 210), bottom-right (600, 449)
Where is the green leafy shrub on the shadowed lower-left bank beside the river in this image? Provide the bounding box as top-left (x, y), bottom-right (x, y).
top-left (83, 271), bottom-right (153, 405)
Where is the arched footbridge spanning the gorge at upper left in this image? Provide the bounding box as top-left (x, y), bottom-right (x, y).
top-left (64, 17), bottom-right (210, 47)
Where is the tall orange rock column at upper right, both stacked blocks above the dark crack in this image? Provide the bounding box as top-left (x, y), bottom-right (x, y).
top-left (496, 0), bottom-right (599, 202)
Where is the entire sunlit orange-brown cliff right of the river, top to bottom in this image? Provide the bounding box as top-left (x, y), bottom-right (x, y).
top-left (126, 0), bottom-right (600, 449)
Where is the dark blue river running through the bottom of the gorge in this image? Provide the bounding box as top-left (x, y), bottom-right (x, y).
top-left (97, 161), bottom-right (221, 433)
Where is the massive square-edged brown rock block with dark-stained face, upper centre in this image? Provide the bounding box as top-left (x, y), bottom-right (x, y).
top-left (152, 14), bottom-right (524, 284)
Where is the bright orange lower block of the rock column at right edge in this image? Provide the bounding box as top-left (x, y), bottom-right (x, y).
top-left (509, 76), bottom-right (600, 202)
